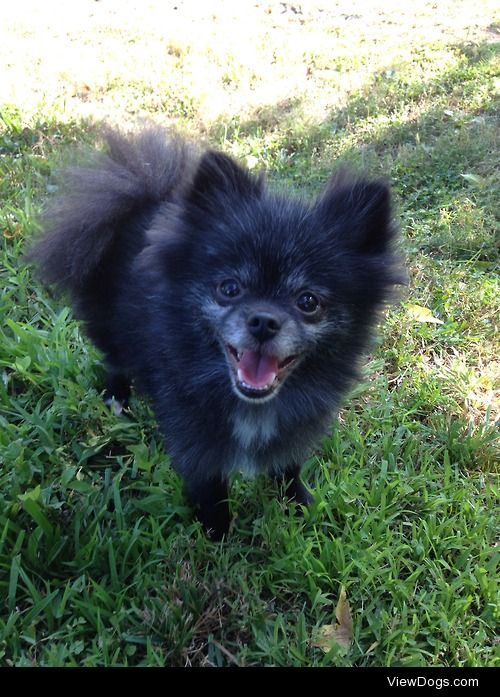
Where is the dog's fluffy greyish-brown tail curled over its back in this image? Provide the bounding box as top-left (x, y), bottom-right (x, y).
top-left (27, 128), bottom-right (191, 291)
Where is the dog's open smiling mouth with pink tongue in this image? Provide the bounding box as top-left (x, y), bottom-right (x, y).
top-left (226, 344), bottom-right (298, 400)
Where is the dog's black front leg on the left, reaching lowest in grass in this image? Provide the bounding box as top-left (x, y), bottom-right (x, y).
top-left (186, 479), bottom-right (231, 541)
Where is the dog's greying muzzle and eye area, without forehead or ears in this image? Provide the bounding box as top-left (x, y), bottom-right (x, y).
top-left (202, 272), bottom-right (331, 403)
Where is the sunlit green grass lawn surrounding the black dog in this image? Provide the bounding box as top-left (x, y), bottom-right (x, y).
top-left (0, 1), bottom-right (500, 666)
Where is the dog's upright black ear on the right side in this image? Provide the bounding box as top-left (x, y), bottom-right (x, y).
top-left (316, 175), bottom-right (396, 254)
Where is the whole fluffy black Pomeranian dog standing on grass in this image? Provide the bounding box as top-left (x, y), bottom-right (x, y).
top-left (29, 128), bottom-right (404, 539)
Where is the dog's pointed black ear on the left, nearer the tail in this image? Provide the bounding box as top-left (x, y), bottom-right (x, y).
top-left (187, 150), bottom-right (263, 210)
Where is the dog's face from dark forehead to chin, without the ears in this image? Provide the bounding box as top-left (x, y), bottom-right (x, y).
top-left (198, 212), bottom-right (356, 404)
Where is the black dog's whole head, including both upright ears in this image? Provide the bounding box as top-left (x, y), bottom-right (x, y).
top-left (162, 153), bottom-right (400, 404)
